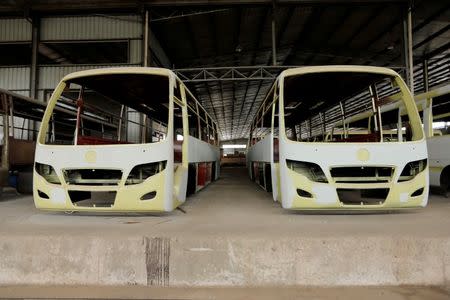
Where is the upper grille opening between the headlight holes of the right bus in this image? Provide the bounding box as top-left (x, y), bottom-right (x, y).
top-left (330, 166), bottom-right (395, 183)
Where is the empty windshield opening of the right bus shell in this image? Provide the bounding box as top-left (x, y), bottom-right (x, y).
top-left (283, 72), bottom-right (422, 143)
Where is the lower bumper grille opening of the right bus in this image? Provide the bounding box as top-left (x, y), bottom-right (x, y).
top-left (337, 189), bottom-right (389, 205)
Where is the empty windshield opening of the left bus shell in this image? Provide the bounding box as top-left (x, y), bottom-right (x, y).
top-left (45, 74), bottom-right (169, 145)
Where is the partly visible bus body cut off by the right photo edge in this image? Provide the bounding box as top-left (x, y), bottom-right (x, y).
top-left (415, 84), bottom-right (450, 195)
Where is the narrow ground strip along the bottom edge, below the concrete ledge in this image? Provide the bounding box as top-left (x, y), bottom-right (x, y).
top-left (0, 285), bottom-right (450, 300)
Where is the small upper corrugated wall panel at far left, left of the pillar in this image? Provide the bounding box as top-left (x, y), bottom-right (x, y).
top-left (0, 19), bottom-right (31, 42)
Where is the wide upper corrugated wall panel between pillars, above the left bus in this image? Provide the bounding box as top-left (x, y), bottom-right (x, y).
top-left (41, 15), bottom-right (142, 41)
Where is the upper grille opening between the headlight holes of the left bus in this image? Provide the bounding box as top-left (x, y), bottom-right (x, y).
top-left (63, 169), bottom-right (122, 186)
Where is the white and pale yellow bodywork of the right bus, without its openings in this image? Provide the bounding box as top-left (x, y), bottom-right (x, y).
top-left (247, 66), bottom-right (428, 210)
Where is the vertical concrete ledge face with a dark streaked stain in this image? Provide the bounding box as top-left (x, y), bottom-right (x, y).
top-left (0, 236), bottom-right (450, 287)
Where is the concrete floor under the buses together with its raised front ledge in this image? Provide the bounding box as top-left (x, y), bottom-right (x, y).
top-left (0, 168), bottom-right (450, 299)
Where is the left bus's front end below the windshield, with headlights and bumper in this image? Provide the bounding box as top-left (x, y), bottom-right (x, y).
top-left (33, 143), bottom-right (174, 212)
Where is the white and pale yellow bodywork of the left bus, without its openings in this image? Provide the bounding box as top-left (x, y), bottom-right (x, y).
top-left (33, 68), bottom-right (219, 212)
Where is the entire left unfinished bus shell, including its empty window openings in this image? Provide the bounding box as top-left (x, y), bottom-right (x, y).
top-left (33, 68), bottom-right (219, 212)
